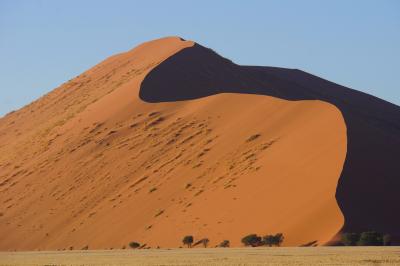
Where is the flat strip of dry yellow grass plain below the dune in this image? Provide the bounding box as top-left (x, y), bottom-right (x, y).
top-left (0, 247), bottom-right (400, 265)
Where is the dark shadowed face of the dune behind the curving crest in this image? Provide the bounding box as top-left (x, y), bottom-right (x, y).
top-left (140, 45), bottom-right (400, 239)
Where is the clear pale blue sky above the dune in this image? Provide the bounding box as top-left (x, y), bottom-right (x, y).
top-left (0, 0), bottom-right (400, 116)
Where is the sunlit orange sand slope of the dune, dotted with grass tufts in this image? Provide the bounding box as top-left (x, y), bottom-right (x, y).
top-left (0, 37), bottom-right (347, 250)
